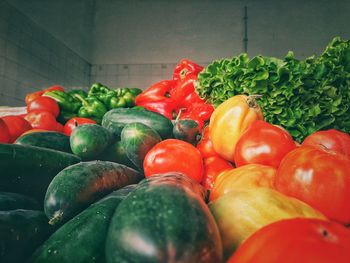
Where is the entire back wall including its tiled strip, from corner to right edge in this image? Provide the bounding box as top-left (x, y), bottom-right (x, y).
top-left (91, 0), bottom-right (350, 88)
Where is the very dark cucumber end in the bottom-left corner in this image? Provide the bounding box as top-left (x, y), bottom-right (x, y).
top-left (0, 209), bottom-right (52, 263)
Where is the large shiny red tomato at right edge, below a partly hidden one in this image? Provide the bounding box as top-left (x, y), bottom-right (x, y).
top-left (275, 146), bottom-right (350, 224)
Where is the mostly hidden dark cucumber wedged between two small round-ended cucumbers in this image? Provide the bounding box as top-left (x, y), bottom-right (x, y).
top-left (101, 140), bottom-right (137, 169)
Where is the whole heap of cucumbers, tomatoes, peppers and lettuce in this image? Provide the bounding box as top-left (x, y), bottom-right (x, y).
top-left (0, 38), bottom-right (350, 263)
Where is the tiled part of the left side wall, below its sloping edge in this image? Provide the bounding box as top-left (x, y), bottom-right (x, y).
top-left (0, 0), bottom-right (90, 106)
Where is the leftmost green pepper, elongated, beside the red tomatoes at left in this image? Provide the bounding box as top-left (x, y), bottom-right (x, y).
top-left (43, 90), bottom-right (81, 113)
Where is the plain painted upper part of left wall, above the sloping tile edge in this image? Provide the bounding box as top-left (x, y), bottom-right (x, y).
top-left (7, 0), bottom-right (95, 61)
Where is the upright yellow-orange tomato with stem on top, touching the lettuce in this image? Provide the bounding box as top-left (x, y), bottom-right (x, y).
top-left (209, 95), bottom-right (263, 162)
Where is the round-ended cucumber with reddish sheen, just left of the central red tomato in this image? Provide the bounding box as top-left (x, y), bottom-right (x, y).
top-left (121, 122), bottom-right (162, 170)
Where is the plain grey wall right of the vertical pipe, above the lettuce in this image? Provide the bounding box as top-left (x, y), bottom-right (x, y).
top-left (247, 0), bottom-right (350, 58)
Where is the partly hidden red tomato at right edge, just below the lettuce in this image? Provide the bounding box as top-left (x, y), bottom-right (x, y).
top-left (302, 129), bottom-right (350, 157)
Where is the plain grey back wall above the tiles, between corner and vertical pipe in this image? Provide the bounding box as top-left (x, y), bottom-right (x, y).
top-left (91, 0), bottom-right (243, 64)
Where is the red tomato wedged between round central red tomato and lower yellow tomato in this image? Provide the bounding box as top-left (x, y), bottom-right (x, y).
top-left (202, 156), bottom-right (232, 190)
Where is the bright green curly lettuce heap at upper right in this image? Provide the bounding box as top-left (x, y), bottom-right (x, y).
top-left (196, 37), bottom-right (350, 142)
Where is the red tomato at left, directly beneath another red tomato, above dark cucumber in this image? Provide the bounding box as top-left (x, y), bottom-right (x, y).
top-left (25, 111), bottom-right (61, 131)
